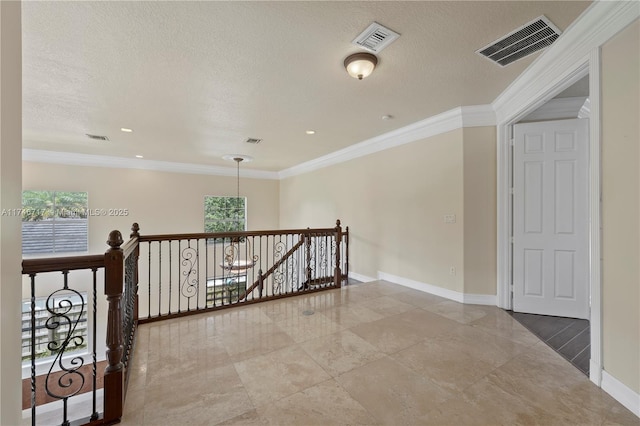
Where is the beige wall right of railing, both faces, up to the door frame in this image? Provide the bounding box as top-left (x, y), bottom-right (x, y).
top-left (280, 128), bottom-right (496, 294)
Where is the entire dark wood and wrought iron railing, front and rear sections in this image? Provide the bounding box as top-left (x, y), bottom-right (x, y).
top-left (22, 220), bottom-right (349, 425)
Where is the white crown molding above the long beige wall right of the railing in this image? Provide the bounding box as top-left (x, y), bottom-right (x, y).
top-left (279, 105), bottom-right (496, 179)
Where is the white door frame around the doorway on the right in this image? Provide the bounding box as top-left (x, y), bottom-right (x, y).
top-left (497, 48), bottom-right (602, 386)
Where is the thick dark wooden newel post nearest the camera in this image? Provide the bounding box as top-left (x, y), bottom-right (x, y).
top-left (104, 231), bottom-right (124, 423)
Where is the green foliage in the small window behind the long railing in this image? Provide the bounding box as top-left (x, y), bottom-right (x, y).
top-left (204, 196), bottom-right (247, 232)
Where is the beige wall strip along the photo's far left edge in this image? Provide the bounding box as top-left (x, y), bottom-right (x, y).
top-left (0, 1), bottom-right (22, 425)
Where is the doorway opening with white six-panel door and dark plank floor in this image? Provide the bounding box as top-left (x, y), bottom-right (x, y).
top-left (511, 75), bottom-right (590, 376)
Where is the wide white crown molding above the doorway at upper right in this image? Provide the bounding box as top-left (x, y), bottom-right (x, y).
top-left (492, 1), bottom-right (640, 123)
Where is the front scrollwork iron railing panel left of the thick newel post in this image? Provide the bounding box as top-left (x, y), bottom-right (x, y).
top-left (22, 255), bottom-right (104, 425)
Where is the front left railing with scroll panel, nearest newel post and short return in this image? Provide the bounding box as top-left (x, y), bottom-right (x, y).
top-left (22, 226), bottom-right (138, 425)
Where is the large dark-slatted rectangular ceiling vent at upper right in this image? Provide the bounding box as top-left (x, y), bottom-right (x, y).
top-left (476, 15), bottom-right (560, 67)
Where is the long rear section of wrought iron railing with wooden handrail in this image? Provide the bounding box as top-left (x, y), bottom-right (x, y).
top-left (138, 221), bottom-right (349, 323)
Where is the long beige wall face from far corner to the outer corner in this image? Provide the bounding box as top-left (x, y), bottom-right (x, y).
top-left (280, 130), bottom-right (463, 291)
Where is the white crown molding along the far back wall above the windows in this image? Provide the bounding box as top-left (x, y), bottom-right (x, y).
top-left (22, 148), bottom-right (278, 180)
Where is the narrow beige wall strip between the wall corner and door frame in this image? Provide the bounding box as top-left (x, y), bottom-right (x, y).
top-left (463, 127), bottom-right (497, 294)
